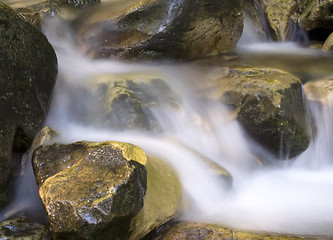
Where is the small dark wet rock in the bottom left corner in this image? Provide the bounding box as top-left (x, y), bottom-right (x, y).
top-left (0, 217), bottom-right (52, 240)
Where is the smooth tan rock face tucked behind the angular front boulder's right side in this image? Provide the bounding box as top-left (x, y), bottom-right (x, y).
top-left (130, 156), bottom-right (181, 240)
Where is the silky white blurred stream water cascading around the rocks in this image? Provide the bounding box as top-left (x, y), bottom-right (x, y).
top-left (0, 17), bottom-right (333, 236)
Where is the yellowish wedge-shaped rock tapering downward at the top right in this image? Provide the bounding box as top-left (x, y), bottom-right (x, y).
top-left (254, 0), bottom-right (297, 41)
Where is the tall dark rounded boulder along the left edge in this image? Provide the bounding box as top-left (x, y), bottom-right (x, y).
top-left (0, 2), bottom-right (57, 206)
